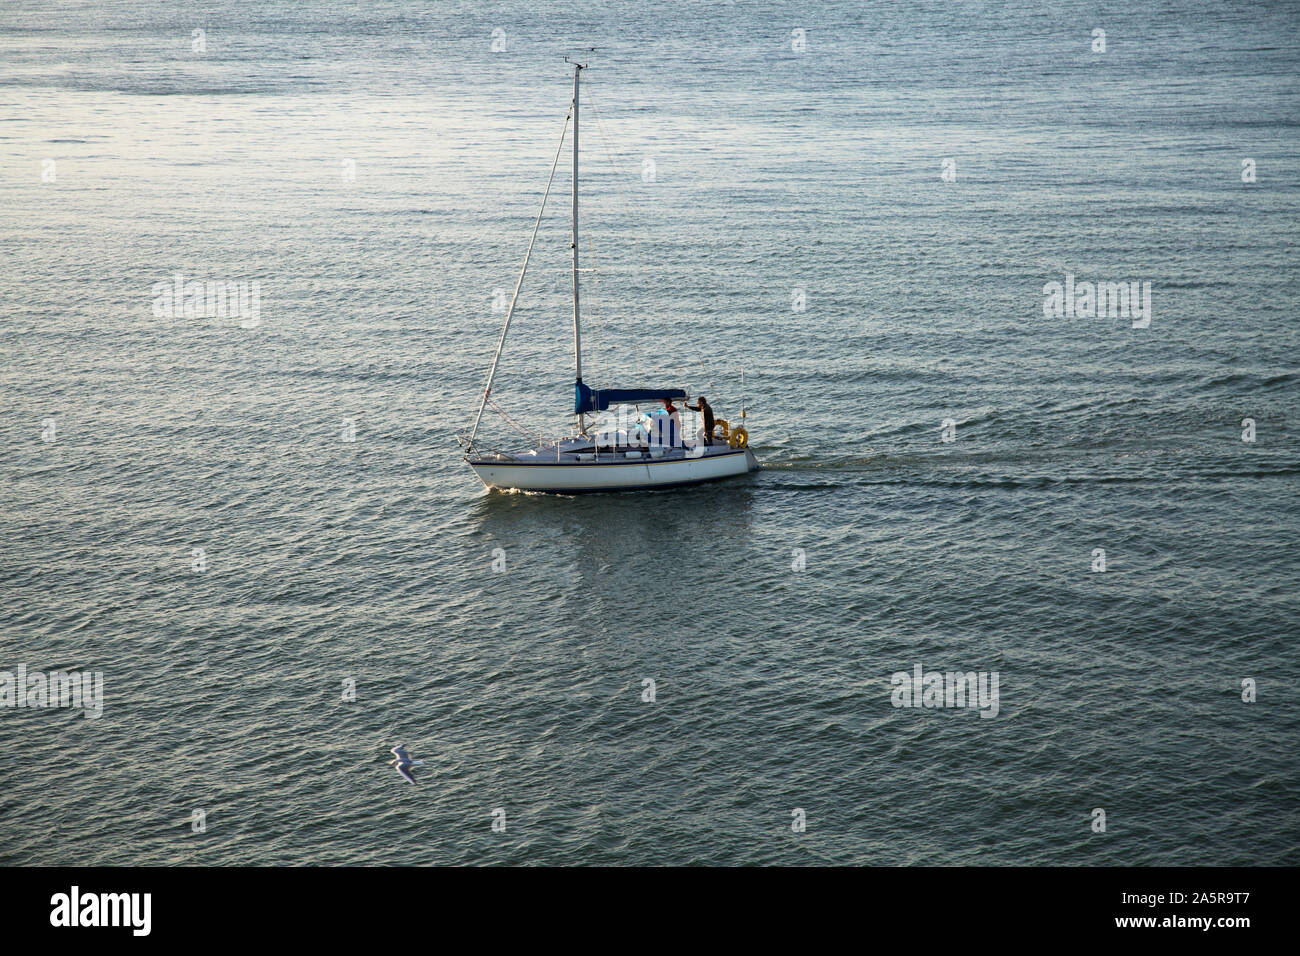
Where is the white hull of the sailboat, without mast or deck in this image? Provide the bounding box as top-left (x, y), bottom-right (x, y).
top-left (469, 449), bottom-right (758, 494)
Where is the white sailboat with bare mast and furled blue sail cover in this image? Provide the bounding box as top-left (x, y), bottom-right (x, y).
top-left (458, 57), bottom-right (759, 494)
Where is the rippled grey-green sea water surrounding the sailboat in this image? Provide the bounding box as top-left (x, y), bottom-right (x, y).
top-left (0, 0), bottom-right (1300, 865)
